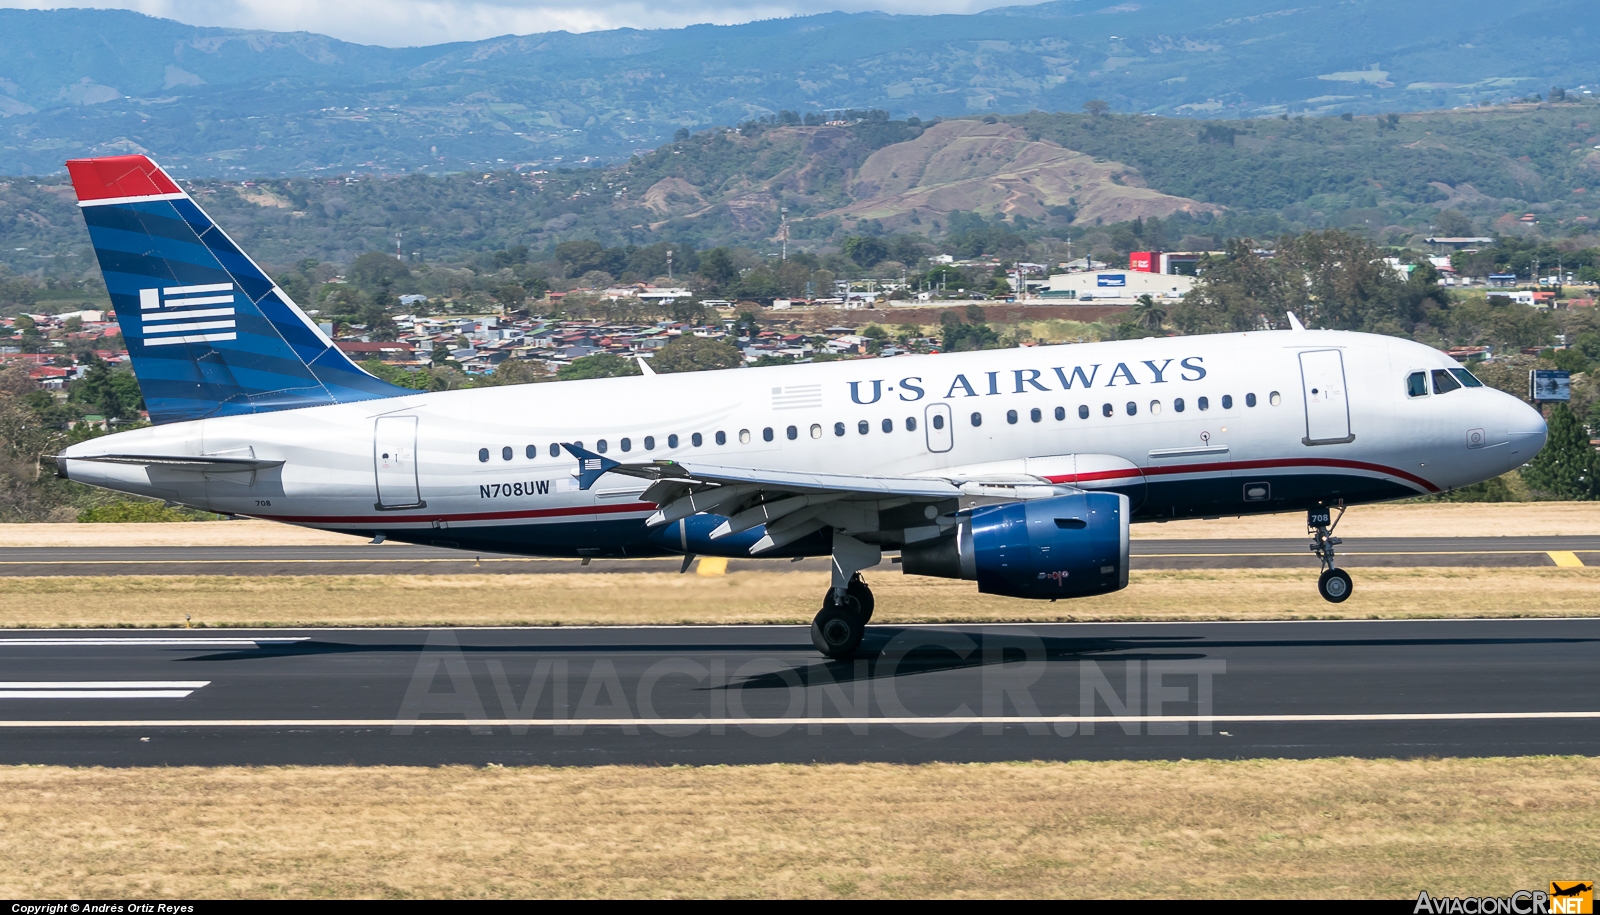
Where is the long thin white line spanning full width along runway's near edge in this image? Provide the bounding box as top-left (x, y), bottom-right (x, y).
top-left (0, 712), bottom-right (1600, 728)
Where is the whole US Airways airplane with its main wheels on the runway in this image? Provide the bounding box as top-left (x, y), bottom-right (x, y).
top-left (56, 155), bottom-right (1546, 657)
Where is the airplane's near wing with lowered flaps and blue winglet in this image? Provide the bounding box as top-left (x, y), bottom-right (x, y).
top-left (563, 445), bottom-right (1074, 553)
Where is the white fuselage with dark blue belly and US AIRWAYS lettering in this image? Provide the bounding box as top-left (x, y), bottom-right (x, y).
top-left (61, 331), bottom-right (1544, 555)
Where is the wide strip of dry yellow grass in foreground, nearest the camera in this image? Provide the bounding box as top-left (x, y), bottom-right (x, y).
top-left (0, 757), bottom-right (1600, 899)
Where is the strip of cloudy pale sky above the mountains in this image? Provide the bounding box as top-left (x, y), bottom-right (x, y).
top-left (0, 0), bottom-right (1029, 48)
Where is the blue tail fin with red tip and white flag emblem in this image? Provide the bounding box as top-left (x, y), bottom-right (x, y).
top-left (67, 155), bottom-right (416, 422)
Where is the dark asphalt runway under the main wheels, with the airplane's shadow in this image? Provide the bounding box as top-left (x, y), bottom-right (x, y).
top-left (0, 620), bottom-right (1600, 766)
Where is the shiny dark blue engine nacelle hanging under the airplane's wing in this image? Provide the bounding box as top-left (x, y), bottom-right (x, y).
top-left (901, 493), bottom-right (1130, 598)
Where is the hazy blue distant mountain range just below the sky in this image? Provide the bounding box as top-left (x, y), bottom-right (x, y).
top-left (0, 0), bottom-right (1600, 176)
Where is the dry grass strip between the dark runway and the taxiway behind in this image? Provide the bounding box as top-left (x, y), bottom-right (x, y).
top-left (0, 568), bottom-right (1600, 627)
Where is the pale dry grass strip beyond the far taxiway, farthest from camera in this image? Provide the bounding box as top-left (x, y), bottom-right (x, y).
top-left (0, 502), bottom-right (1600, 547)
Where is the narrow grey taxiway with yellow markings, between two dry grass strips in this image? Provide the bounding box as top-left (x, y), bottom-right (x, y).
top-left (0, 536), bottom-right (1600, 576)
